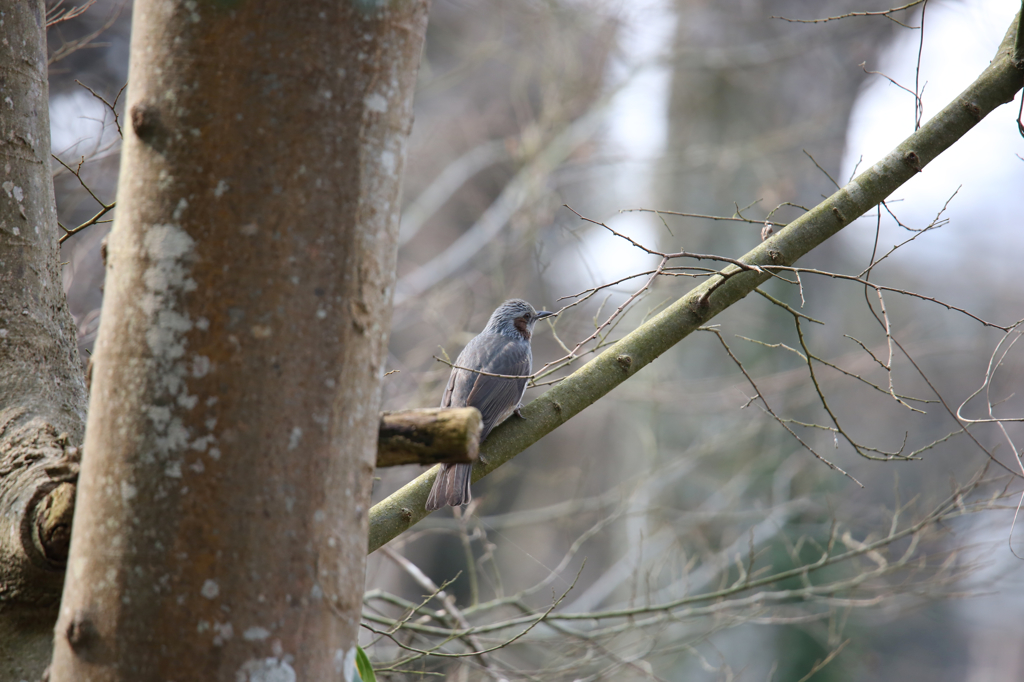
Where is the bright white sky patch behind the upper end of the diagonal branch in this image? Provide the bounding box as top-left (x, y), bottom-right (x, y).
top-left (840, 0), bottom-right (1024, 287)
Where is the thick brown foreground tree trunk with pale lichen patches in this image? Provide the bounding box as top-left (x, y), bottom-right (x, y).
top-left (50, 0), bottom-right (427, 682)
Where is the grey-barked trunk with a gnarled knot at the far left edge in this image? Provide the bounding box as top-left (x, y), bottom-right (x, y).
top-left (0, 0), bottom-right (86, 682)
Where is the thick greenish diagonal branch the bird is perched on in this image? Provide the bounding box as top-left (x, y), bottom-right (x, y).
top-left (370, 11), bottom-right (1022, 552)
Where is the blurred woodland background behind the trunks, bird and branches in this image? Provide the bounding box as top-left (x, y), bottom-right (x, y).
top-left (50, 0), bottom-right (1024, 680)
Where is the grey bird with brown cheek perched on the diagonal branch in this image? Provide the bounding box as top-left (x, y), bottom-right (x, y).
top-left (426, 298), bottom-right (555, 511)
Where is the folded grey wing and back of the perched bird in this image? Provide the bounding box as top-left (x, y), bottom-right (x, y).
top-left (456, 334), bottom-right (534, 440)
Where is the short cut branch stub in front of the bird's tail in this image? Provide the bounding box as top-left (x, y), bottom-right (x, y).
top-left (377, 408), bottom-right (483, 467)
